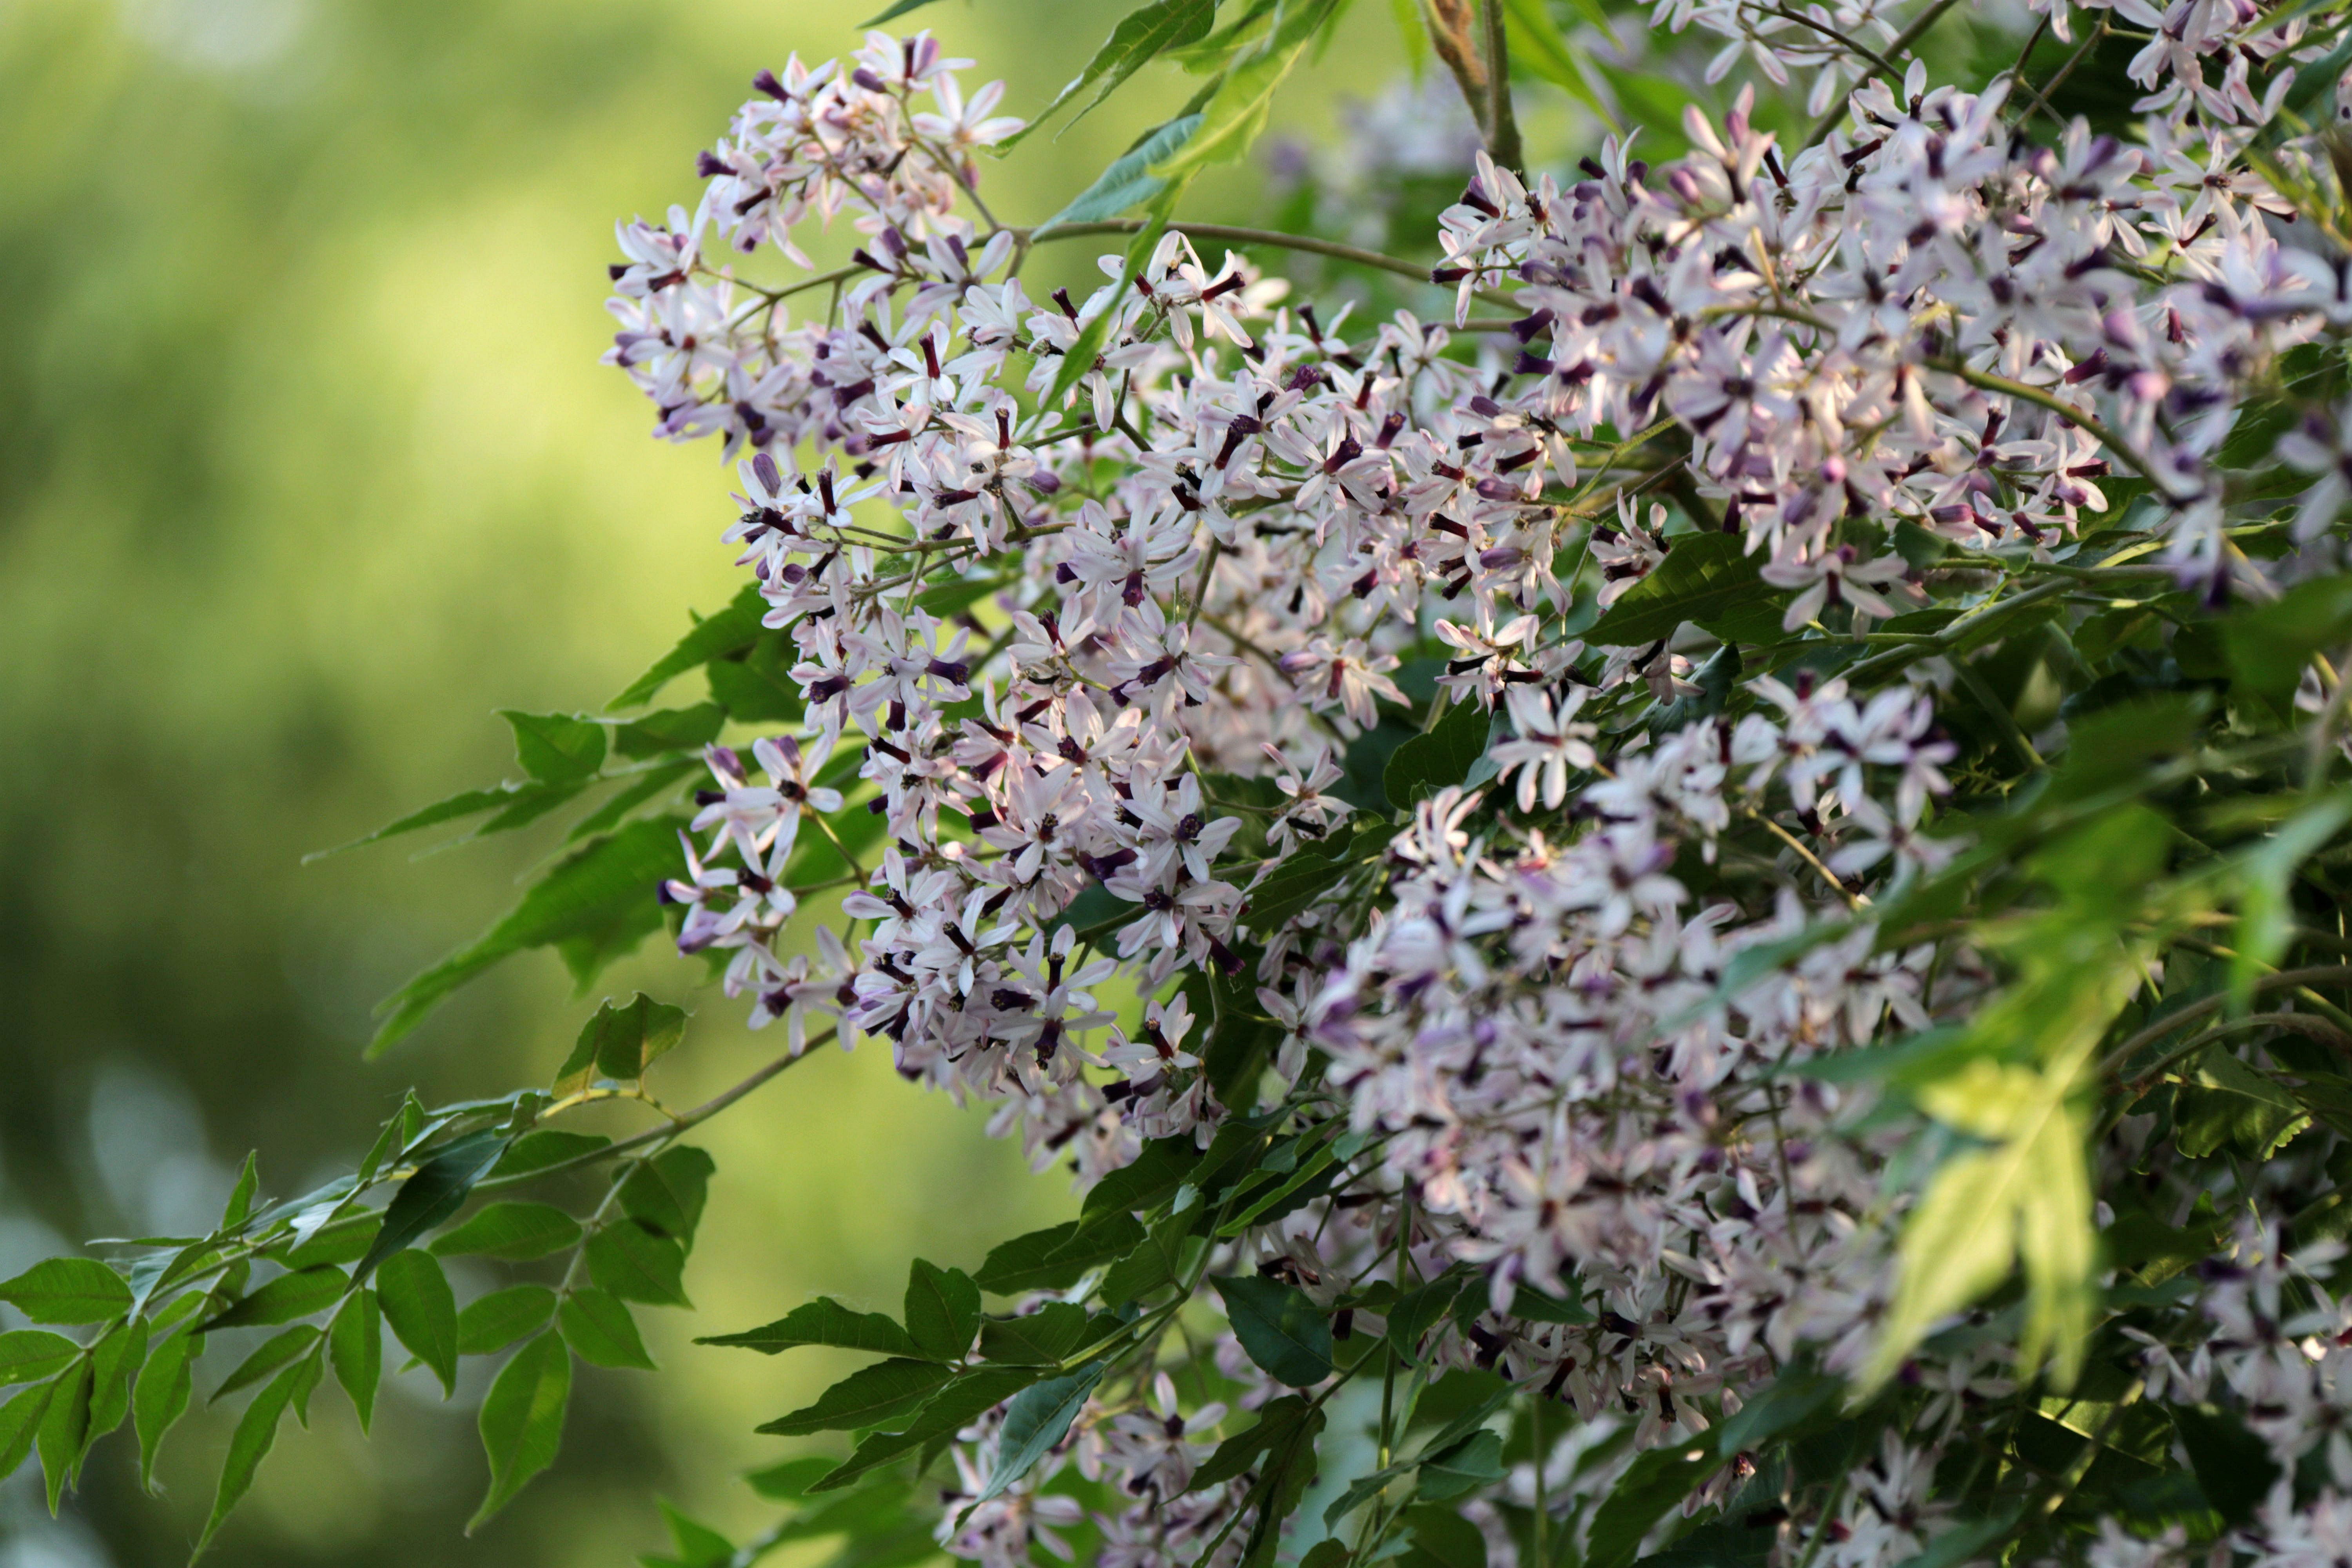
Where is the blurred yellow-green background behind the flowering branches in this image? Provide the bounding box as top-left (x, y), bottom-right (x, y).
top-left (0, 0), bottom-right (1486, 1568)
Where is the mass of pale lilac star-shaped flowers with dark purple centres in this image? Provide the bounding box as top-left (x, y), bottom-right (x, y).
top-left (612, 12), bottom-right (2352, 1568)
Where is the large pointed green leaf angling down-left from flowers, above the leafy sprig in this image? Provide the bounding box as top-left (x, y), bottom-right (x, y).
top-left (367, 818), bottom-right (677, 1056)
